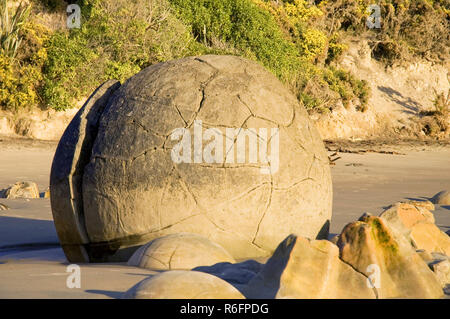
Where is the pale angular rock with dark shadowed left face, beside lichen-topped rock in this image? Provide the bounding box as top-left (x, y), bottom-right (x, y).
top-left (242, 235), bottom-right (376, 299)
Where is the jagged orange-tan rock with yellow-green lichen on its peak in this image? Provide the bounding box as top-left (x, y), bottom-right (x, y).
top-left (337, 216), bottom-right (443, 298)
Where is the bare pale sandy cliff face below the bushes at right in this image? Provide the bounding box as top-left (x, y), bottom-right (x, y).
top-left (311, 41), bottom-right (450, 139)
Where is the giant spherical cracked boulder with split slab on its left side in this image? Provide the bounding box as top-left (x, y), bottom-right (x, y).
top-left (51, 55), bottom-right (332, 262)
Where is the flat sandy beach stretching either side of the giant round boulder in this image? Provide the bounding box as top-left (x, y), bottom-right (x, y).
top-left (0, 139), bottom-right (450, 298)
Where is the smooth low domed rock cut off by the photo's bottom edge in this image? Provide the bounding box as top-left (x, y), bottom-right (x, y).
top-left (123, 270), bottom-right (245, 299)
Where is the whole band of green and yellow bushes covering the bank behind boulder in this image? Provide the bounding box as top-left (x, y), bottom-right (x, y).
top-left (0, 0), bottom-right (450, 117)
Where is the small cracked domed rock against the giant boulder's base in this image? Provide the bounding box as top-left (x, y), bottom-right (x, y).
top-left (128, 233), bottom-right (235, 270)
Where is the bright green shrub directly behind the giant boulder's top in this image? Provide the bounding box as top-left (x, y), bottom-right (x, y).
top-left (169, 0), bottom-right (299, 78)
